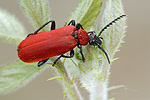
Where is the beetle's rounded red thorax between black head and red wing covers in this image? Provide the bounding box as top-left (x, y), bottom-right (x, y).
top-left (72, 29), bottom-right (89, 45)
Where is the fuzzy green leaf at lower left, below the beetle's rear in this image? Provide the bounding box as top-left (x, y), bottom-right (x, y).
top-left (0, 60), bottom-right (46, 94)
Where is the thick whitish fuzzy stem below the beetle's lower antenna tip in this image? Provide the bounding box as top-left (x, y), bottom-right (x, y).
top-left (90, 61), bottom-right (110, 100)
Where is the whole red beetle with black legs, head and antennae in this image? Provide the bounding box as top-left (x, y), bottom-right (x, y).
top-left (17, 15), bottom-right (125, 67)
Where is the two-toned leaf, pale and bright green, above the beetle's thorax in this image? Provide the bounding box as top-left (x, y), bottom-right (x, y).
top-left (69, 0), bottom-right (102, 30)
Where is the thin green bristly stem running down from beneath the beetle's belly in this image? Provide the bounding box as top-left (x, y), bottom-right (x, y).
top-left (56, 62), bottom-right (83, 100)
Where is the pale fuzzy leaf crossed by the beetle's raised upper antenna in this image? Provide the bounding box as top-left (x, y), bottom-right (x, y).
top-left (101, 0), bottom-right (127, 58)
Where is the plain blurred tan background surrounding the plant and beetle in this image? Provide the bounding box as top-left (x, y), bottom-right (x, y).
top-left (0, 0), bottom-right (150, 100)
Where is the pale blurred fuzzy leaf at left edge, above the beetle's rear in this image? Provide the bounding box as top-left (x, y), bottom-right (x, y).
top-left (0, 9), bottom-right (26, 44)
